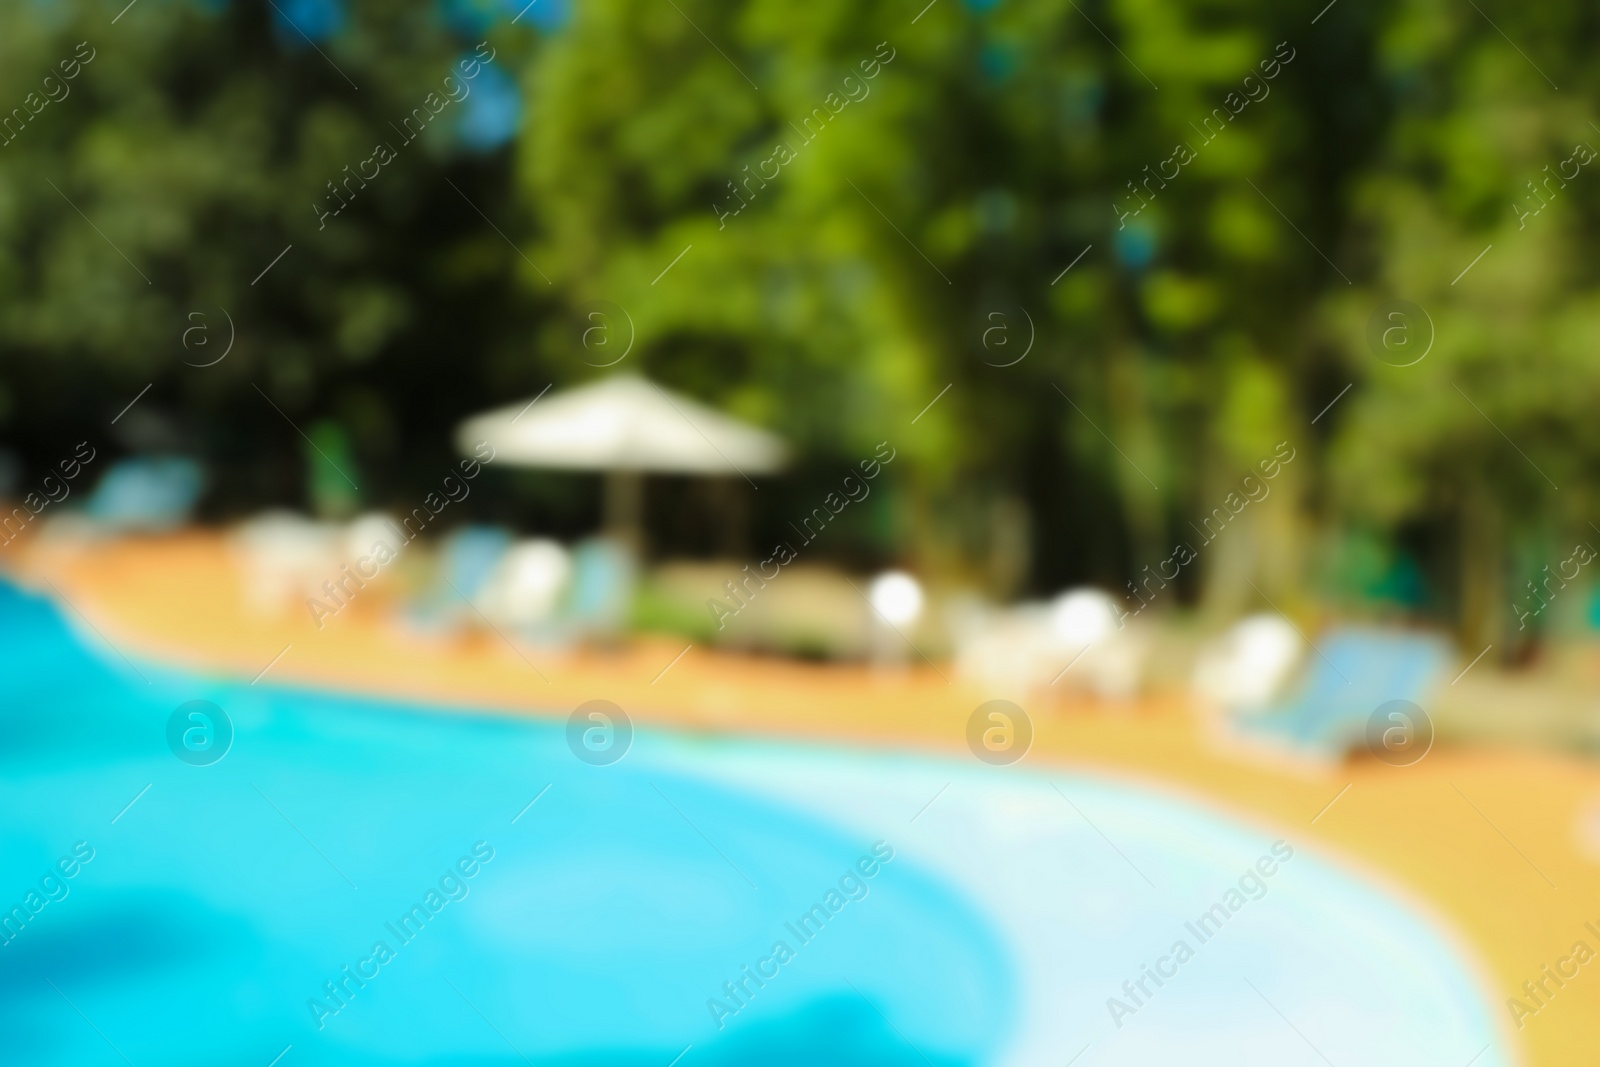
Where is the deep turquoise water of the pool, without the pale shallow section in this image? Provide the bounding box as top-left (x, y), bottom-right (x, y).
top-left (0, 585), bottom-right (1013, 1067)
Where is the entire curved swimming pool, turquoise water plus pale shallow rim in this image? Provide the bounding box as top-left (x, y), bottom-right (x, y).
top-left (0, 585), bottom-right (1509, 1067)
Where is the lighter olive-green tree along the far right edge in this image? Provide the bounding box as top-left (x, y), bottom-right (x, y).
top-left (1325, 3), bottom-right (1600, 651)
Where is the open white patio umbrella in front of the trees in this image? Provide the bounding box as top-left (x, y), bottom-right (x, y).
top-left (456, 374), bottom-right (787, 545)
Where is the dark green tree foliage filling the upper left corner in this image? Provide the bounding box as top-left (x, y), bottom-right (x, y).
top-left (0, 0), bottom-right (547, 514)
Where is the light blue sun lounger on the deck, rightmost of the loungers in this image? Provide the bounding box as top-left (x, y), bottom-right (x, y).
top-left (1234, 627), bottom-right (1450, 761)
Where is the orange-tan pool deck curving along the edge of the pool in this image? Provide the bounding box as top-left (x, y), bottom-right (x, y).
top-left (15, 533), bottom-right (1600, 1067)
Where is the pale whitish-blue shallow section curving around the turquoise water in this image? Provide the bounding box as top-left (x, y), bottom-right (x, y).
top-left (691, 742), bottom-right (1517, 1067)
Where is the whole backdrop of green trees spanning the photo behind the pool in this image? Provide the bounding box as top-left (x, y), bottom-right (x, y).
top-left (0, 0), bottom-right (1600, 633)
